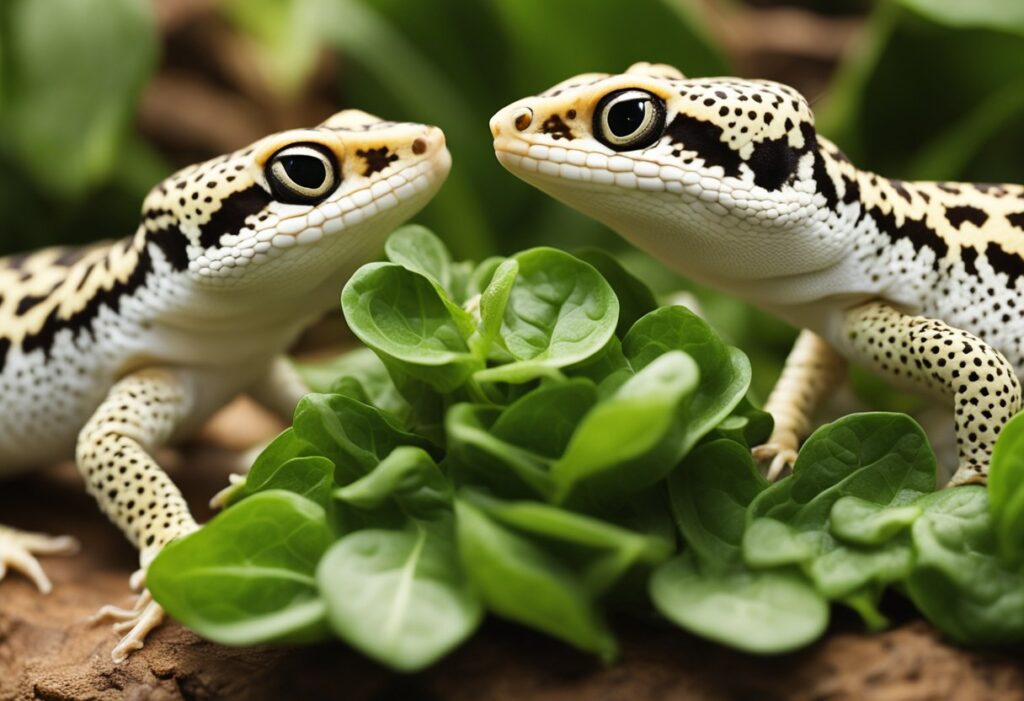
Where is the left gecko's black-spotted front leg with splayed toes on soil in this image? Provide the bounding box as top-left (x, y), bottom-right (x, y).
top-left (77, 369), bottom-right (198, 662)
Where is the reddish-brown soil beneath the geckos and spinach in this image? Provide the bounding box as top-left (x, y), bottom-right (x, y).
top-left (0, 399), bottom-right (1024, 701)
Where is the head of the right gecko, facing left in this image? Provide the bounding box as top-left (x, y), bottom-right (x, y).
top-left (490, 63), bottom-right (835, 279)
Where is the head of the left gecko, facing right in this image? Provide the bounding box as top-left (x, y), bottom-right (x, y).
top-left (138, 109), bottom-right (451, 294)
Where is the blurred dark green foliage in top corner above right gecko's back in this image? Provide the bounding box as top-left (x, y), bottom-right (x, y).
top-left (815, 0), bottom-right (1024, 182)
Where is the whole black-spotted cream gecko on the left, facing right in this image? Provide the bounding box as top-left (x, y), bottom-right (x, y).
top-left (0, 109), bottom-right (451, 660)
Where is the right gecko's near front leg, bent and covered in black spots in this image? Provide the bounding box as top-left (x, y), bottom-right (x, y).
top-left (843, 302), bottom-right (1021, 485)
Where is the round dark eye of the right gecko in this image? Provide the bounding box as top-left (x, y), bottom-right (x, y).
top-left (594, 90), bottom-right (665, 150)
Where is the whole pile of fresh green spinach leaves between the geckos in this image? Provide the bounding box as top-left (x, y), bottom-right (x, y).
top-left (148, 227), bottom-right (1024, 670)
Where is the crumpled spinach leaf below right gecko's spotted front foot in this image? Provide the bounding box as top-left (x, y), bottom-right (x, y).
top-left (907, 486), bottom-right (1024, 645)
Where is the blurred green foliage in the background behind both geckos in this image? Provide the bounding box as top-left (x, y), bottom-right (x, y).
top-left (6, 0), bottom-right (1024, 395)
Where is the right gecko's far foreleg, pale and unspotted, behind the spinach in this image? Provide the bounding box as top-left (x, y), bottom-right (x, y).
top-left (754, 331), bottom-right (846, 481)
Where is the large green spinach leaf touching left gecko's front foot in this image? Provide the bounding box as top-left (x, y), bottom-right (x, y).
top-left (146, 490), bottom-right (334, 645)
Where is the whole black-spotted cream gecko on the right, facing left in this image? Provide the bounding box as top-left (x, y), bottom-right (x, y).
top-left (490, 63), bottom-right (1024, 483)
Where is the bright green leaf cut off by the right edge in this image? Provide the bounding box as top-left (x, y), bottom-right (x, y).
top-left (988, 412), bottom-right (1024, 559)
